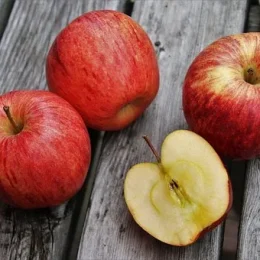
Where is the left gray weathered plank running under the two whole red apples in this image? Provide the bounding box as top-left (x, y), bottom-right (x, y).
top-left (0, 0), bottom-right (124, 260)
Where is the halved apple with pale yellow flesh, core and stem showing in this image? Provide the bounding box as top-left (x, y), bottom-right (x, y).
top-left (124, 130), bottom-right (232, 246)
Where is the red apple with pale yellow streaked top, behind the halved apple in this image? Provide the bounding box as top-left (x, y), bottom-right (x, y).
top-left (183, 33), bottom-right (260, 159)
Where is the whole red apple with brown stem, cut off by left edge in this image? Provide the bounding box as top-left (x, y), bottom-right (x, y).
top-left (0, 90), bottom-right (91, 209)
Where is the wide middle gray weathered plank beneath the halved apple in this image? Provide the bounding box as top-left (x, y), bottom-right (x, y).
top-left (78, 0), bottom-right (247, 260)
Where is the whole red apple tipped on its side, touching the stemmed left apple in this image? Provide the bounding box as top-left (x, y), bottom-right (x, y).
top-left (46, 10), bottom-right (159, 131)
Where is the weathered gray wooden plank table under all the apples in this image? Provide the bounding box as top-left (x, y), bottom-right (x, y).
top-left (0, 0), bottom-right (260, 260)
